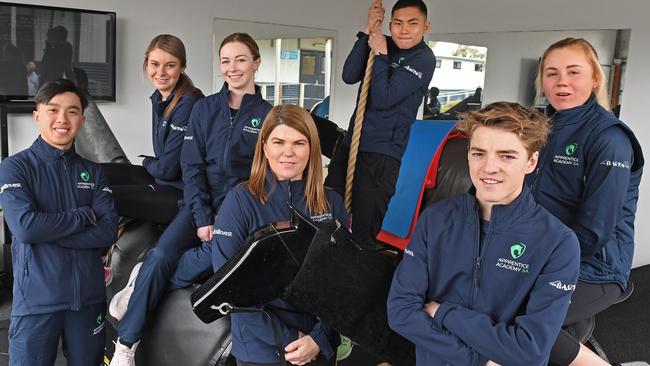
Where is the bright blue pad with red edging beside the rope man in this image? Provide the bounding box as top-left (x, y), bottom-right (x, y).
top-left (381, 120), bottom-right (458, 238)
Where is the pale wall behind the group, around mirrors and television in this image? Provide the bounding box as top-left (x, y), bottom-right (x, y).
top-left (9, 0), bottom-right (650, 265)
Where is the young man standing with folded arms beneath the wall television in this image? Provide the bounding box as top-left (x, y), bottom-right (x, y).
top-left (0, 79), bottom-right (117, 366)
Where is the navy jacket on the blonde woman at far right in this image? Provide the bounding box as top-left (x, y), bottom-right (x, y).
top-left (526, 95), bottom-right (644, 288)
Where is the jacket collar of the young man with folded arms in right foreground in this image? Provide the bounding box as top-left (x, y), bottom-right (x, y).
top-left (464, 183), bottom-right (536, 227)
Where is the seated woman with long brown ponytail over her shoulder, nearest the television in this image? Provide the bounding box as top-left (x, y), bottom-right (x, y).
top-left (102, 34), bottom-right (203, 224)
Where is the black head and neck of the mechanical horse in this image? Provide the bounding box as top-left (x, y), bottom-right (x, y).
top-left (187, 204), bottom-right (415, 366)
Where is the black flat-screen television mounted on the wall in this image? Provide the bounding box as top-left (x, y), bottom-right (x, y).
top-left (0, 2), bottom-right (116, 102)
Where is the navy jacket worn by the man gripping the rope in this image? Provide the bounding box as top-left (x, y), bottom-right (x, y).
top-left (343, 32), bottom-right (436, 161)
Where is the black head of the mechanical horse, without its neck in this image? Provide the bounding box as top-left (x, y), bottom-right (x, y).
top-left (192, 205), bottom-right (347, 323)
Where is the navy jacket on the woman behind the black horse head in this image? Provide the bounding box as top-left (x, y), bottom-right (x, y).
top-left (172, 173), bottom-right (349, 363)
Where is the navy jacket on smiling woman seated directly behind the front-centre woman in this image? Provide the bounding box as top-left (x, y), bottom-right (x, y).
top-left (181, 83), bottom-right (272, 227)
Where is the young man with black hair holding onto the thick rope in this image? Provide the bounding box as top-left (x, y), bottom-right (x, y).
top-left (325, 0), bottom-right (436, 249)
